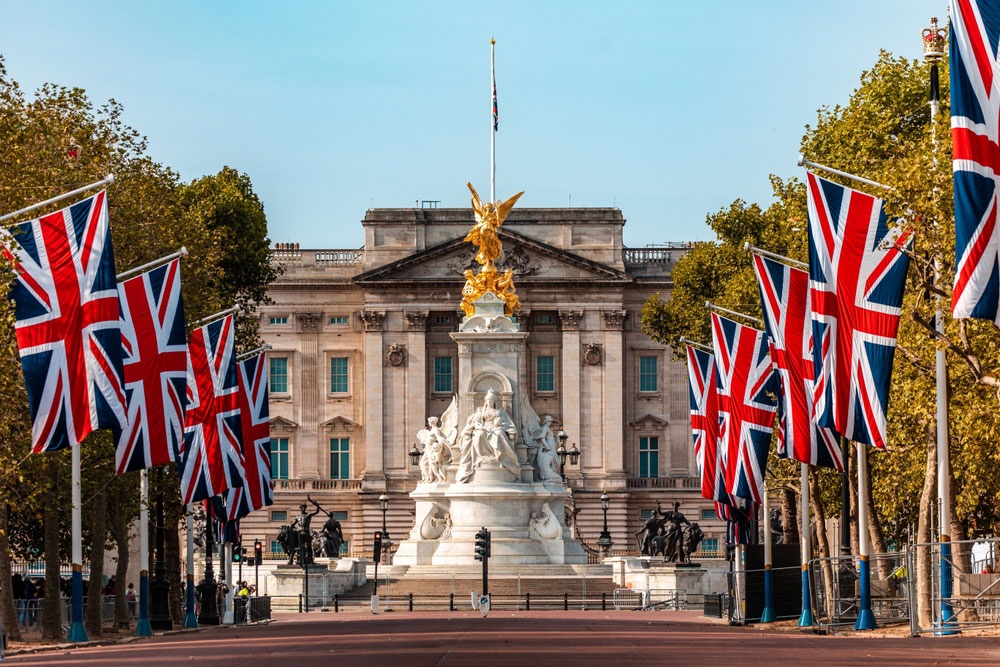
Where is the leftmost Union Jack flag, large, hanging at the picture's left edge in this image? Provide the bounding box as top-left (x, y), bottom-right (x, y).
top-left (10, 190), bottom-right (126, 453)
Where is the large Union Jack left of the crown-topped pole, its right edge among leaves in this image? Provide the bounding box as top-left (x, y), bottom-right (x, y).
top-left (807, 173), bottom-right (912, 449)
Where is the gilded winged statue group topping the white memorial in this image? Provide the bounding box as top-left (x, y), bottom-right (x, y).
top-left (462, 183), bottom-right (524, 317)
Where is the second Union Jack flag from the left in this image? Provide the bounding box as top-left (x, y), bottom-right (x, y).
top-left (115, 259), bottom-right (187, 475)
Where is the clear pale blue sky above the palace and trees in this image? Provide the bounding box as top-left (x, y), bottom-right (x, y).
top-left (0, 0), bottom-right (947, 248)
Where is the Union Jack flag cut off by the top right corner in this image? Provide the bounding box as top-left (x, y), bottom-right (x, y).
top-left (950, 0), bottom-right (1000, 325)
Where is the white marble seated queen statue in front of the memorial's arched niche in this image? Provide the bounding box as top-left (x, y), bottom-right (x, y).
top-left (455, 389), bottom-right (521, 484)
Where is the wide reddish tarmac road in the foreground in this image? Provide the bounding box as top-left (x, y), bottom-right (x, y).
top-left (6, 611), bottom-right (1000, 667)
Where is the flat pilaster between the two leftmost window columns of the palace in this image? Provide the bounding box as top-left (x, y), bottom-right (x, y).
top-left (289, 313), bottom-right (325, 479)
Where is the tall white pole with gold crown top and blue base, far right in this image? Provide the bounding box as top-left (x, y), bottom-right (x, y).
top-left (922, 17), bottom-right (960, 635)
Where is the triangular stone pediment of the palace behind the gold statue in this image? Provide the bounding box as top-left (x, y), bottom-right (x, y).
top-left (354, 228), bottom-right (632, 286)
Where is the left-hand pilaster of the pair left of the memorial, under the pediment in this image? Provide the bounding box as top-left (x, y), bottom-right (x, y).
top-left (362, 310), bottom-right (385, 490)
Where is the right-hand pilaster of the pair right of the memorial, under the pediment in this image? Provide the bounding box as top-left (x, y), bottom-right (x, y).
top-left (601, 310), bottom-right (628, 486)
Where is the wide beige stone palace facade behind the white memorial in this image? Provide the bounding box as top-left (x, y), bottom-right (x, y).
top-left (243, 208), bottom-right (724, 552)
